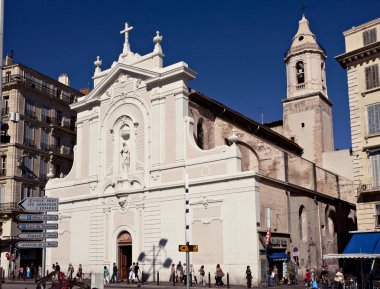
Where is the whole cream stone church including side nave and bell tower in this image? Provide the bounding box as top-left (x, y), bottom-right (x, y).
top-left (46, 18), bottom-right (356, 284)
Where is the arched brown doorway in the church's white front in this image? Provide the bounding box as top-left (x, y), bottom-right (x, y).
top-left (117, 231), bottom-right (132, 280)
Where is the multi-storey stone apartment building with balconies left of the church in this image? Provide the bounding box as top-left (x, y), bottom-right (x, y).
top-left (0, 55), bottom-right (83, 274)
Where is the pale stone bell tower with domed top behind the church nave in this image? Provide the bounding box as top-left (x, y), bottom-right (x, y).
top-left (282, 15), bottom-right (334, 166)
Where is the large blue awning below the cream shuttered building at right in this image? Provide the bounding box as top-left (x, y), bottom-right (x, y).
top-left (343, 232), bottom-right (380, 254)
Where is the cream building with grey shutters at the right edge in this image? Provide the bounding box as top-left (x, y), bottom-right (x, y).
top-left (336, 18), bottom-right (380, 231)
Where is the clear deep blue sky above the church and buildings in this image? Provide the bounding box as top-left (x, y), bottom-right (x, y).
top-left (4, 0), bottom-right (380, 149)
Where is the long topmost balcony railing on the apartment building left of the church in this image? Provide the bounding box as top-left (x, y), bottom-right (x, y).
top-left (3, 74), bottom-right (76, 104)
